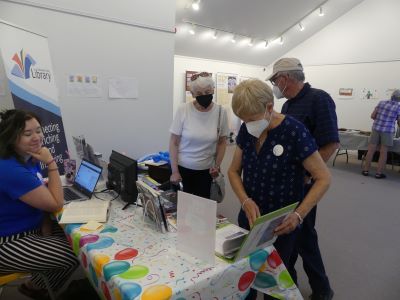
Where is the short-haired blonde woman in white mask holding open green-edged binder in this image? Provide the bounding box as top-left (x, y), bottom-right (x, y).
top-left (228, 79), bottom-right (330, 299)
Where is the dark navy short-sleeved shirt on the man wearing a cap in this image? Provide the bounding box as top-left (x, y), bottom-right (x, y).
top-left (282, 83), bottom-right (339, 148)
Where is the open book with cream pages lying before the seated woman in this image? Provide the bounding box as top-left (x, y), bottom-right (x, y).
top-left (59, 199), bottom-right (110, 224)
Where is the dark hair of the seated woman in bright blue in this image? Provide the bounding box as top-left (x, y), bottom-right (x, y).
top-left (0, 109), bottom-right (41, 163)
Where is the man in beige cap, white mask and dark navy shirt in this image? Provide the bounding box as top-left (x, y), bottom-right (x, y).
top-left (266, 58), bottom-right (339, 300)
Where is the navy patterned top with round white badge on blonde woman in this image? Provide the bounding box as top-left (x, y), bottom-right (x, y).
top-left (236, 116), bottom-right (317, 215)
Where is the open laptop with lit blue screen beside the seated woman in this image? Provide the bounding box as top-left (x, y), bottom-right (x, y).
top-left (63, 159), bottom-right (103, 202)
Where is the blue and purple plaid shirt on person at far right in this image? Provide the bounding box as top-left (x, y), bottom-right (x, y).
top-left (372, 100), bottom-right (400, 133)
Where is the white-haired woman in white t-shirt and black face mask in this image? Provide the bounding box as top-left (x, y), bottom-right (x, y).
top-left (169, 72), bottom-right (229, 198)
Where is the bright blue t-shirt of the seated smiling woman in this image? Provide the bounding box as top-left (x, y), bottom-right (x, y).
top-left (0, 158), bottom-right (43, 236)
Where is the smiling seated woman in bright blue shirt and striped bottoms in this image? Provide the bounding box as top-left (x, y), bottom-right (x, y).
top-left (0, 110), bottom-right (79, 299)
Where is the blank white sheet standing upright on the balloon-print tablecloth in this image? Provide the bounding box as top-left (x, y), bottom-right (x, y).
top-left (177, 191), bottom-right (217, 264)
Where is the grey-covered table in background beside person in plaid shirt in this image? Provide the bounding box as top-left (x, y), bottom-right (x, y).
top-left (332, 130), bottom-right (400, 166)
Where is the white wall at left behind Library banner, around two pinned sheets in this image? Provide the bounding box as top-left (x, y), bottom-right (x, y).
top-left (0, 0), bottom-right (175, 158)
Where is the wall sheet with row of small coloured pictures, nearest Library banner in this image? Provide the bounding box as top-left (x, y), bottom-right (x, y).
top-left (67, 74), bottom-right (102, 98)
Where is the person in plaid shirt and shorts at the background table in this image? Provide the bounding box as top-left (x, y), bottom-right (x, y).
top-left (362, 90), bottom-right (400, 179)
